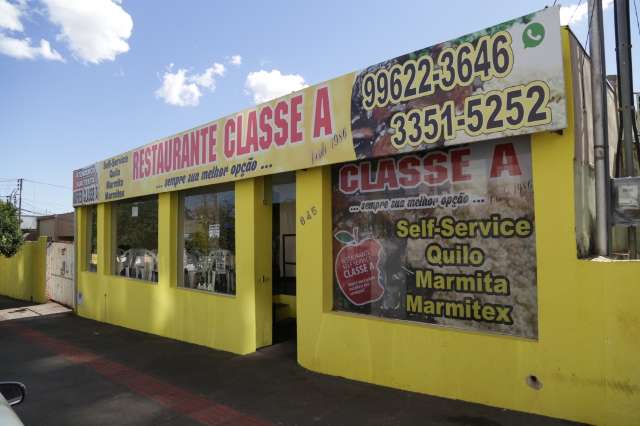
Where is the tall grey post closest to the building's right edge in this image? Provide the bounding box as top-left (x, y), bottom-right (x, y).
top-left (589, 0), bottom-right (609, 256)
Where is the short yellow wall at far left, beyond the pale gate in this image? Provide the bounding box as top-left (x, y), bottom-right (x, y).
top-left (0, 237), bottom-right (47, 303)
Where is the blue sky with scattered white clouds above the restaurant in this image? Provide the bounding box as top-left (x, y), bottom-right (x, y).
top-left (0, 0), bottom-right (640, 212)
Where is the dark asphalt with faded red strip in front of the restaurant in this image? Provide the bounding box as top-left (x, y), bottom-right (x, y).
top-left (0, 304), bottom-right (580, 426)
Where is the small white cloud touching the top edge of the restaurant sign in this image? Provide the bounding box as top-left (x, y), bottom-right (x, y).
top-left (245, 69), bottom-right (308, 104)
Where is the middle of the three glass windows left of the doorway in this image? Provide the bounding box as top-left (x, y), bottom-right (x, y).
top-left (112, 195), bottom-right (158, 282)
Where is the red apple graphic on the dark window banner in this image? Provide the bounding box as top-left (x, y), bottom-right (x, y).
top-left (335, 230), bottom-right (384, 305)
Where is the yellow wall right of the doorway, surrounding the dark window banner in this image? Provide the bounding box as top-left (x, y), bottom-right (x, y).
top-left (296, 30), bottom-right (640, 425)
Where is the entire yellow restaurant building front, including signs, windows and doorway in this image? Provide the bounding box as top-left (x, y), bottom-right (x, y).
top-left (74, 8), bottom-right (640, 424)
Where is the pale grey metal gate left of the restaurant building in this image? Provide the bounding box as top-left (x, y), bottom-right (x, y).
top-left (46, 243), bottom-right (75, 308)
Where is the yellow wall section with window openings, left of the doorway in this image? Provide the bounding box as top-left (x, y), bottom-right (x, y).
top-left (76, 178), bottom-right (271, 354)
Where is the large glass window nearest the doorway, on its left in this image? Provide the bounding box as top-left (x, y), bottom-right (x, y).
top-left (178, 184), bottom-right (236, 294)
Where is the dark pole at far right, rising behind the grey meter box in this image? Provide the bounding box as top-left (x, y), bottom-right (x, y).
top-left (614, 0), bottom-right (638, 259)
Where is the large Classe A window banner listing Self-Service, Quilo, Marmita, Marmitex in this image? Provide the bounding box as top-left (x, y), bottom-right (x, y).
top-left (333, 136), bottom-right (538, 339)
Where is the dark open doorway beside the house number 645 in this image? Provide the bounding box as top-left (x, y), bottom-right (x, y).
top-left (271, 173), bottom-right (296, 344)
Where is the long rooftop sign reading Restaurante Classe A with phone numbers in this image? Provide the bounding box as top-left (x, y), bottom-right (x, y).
top-left (74, 7), bottom-right (567, 205)
